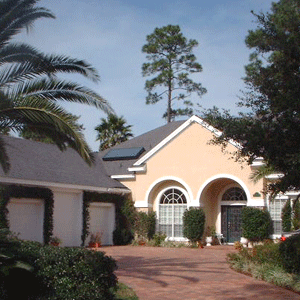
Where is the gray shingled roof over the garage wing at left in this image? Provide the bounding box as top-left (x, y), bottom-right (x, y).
top-left (0, 136), bottom-right (126, 189)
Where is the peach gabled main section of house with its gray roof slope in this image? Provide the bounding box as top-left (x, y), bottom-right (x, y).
top-left (102, 116), bottom-right (266, 242)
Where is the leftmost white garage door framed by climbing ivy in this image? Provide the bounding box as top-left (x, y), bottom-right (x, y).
top-left (7, 199), bottom-right (44, 243)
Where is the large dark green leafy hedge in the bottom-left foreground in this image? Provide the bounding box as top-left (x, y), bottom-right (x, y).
top-left (1, 233), bottom-right (117, 300)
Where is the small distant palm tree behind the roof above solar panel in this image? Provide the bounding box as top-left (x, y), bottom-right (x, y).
top-left (95, 114), bottom-right (133, 151)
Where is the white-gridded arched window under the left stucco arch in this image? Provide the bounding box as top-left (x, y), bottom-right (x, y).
top-left (158, 188), bottom-right (187, 238)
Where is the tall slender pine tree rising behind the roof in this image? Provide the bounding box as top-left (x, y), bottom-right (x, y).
top-left (142, 25), bottom-right (206, 122)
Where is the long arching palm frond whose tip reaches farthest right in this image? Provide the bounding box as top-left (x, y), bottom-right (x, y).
top-left (8, 78), bottom-right (113, 113)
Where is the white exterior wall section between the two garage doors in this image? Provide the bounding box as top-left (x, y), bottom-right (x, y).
top-left (52, 189), bottom-right (83, 246)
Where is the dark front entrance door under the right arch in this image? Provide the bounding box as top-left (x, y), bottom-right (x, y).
top-left (221, 205), bottom-right (243, 243)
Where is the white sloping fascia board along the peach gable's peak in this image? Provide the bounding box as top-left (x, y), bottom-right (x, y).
top-left (133, 116), bottom-right (241, 166)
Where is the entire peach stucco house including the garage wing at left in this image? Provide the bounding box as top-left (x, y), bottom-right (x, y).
top-left (0, 116), bottom-right (295, 246)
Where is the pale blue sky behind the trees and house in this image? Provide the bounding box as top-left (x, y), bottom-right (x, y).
top-left (18, 0), bottom-right (272, 150)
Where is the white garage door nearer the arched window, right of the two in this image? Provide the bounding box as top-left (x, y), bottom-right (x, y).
top-left (87, 203), bottom-right (115, 245)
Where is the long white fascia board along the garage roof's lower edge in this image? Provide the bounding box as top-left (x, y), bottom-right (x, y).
top-left (0, 177), bottom-right (131, 194)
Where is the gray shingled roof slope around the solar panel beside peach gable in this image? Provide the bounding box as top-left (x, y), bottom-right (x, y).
top-left (99, 121), bottom-right (185, 175)
